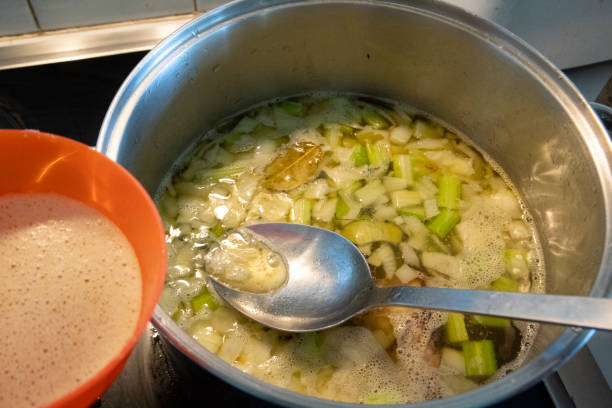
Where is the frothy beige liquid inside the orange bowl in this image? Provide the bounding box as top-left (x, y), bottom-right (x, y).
top-left (0, 194), bottom-right (142, 407)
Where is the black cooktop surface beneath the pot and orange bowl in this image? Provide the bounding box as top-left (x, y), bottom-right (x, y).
top-left (0, 53), bottom-right (554, 408)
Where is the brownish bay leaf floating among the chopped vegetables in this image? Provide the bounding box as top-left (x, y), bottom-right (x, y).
top-left (263, 142), bottom-right (323, 191)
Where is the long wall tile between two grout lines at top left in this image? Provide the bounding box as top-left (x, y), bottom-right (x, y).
top-left (30, 0), bottom-right (194, 30)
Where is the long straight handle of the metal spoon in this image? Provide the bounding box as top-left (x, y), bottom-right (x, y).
top-left (370, 286), bottom-right (612, 331)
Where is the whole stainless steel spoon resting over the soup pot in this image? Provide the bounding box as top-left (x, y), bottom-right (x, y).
top-left (213, 223), bottom-right (612, 332)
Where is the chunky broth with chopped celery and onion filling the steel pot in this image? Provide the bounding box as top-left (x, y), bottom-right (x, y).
top-left (158, 95), bottom-right (544, 403)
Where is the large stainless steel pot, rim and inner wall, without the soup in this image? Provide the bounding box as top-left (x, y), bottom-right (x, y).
top-left (97, 0), bottom-right (612, 407)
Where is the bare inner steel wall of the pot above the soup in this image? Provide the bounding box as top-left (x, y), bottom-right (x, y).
top-left (107, 3), bottom-right (605, 366)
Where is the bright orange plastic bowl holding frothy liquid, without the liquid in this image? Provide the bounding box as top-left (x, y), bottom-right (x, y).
top-left (0, 130), bottom-right (166, 408)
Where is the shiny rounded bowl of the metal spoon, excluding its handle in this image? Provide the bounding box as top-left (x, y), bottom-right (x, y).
top-left (213, 223), bottom-right (375, 332)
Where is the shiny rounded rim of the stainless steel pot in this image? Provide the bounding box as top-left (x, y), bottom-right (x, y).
top-left (96, 0), bottom-right (612, 408)
